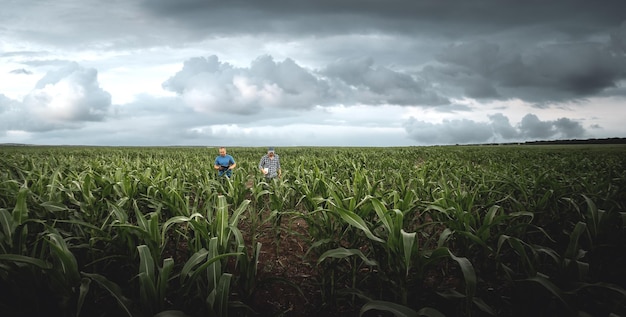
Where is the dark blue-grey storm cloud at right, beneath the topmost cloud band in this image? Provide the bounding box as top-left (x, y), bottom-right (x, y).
top-left (424, 41), bottom-right (626, 103)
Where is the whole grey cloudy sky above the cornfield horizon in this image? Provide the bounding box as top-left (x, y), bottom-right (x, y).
top-left (0, 0), bottom-right (626, 146)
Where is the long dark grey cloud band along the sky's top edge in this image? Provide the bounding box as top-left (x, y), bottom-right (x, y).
top-left (142, 0), bottom-right (626, 36)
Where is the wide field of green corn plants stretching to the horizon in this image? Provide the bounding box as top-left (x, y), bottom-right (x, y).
top-left (0, 145), bottom-right (626, 316)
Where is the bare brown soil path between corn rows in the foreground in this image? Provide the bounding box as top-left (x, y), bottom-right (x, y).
top-left (219, 177), bottom-right (460, 317)
